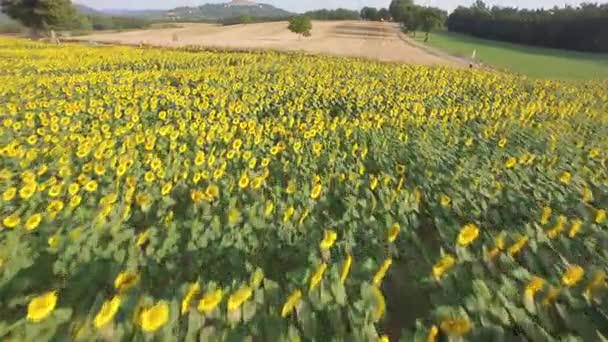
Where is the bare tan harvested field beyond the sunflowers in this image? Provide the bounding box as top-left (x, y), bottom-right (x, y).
top-left (74, 21), bottom-right (462, 66)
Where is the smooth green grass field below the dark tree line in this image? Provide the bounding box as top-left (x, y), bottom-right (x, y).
top-left (416, 31), bottom-right (608, 80)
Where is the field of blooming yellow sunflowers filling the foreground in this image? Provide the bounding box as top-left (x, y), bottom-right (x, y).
top-left (0, 38), bottom-right (608, 341)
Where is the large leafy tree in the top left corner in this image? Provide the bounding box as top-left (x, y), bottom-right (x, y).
top-left (0, 0), bottom-right (76, 36)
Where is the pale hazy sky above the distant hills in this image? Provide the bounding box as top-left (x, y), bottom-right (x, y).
top-left (78, 0), bottom-right (608, 12)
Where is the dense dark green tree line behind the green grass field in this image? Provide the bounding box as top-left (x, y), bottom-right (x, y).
top-left (447, 0), bottom-right (608, 52)
